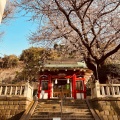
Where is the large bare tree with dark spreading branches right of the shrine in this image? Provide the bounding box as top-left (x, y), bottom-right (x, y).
top-left (17, 0), bottom-right (120, 80)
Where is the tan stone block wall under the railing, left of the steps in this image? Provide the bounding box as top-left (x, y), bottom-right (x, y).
top-left (0, 96), bottom-right (31, 120)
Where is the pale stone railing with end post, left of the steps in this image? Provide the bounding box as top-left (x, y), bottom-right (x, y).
top-left (0, 83), bottom-right (33, 99)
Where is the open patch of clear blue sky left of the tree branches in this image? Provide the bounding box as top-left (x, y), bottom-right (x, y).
top-left (0, 12), bottom-right (37, 57)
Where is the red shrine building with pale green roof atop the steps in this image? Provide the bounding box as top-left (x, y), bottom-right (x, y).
top-left (38, 62), bottom-right (92, 99)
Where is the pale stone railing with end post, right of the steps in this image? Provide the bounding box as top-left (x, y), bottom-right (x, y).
top-left (91, 81), bottom-right (120, 98)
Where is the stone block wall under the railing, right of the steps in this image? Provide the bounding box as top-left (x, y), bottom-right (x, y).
top-left (90, 98), bottom-right (120, 120)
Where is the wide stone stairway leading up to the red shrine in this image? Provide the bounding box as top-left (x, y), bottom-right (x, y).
top-left (29, 100), bottom-right (94, 120)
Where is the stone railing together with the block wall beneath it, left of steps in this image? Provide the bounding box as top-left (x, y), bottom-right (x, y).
top-left (0, 83), bottom-right (33, 120)
